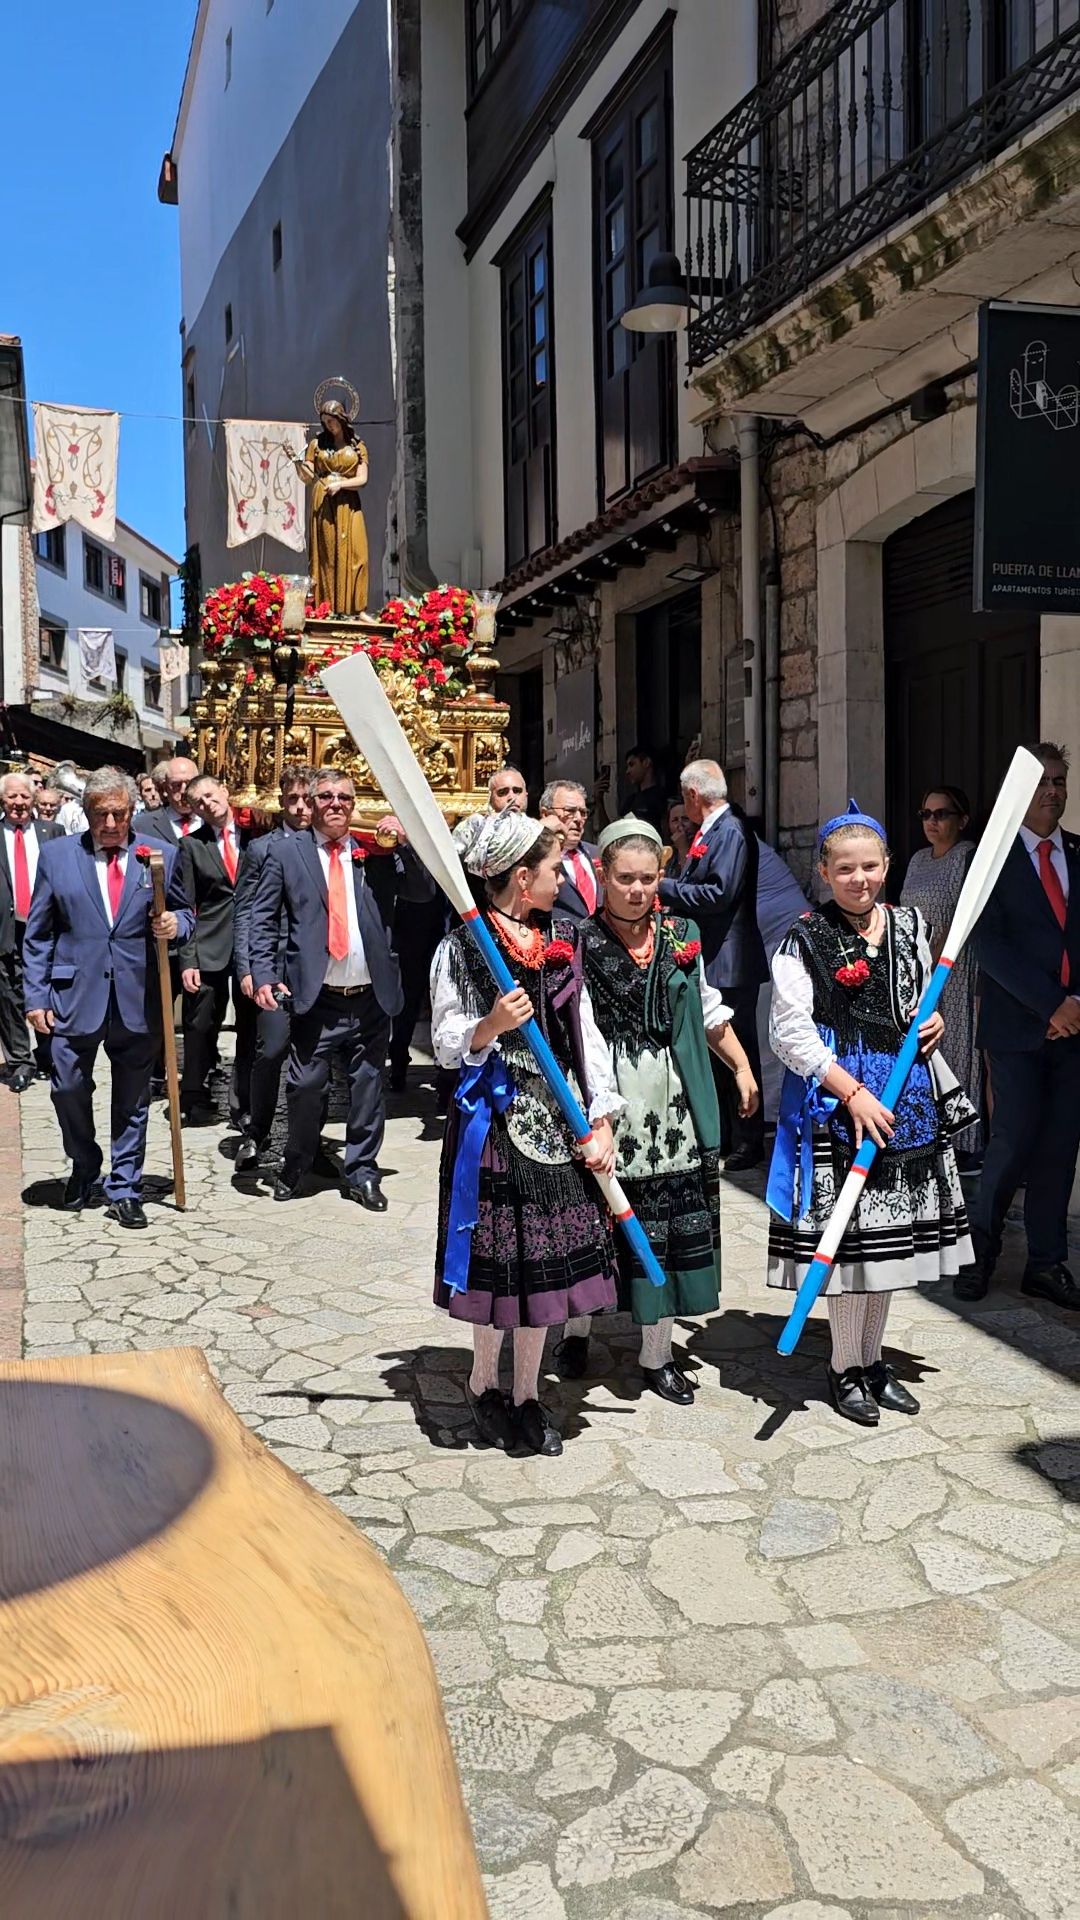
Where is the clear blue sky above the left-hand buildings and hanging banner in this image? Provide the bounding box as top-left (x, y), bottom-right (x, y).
top-left (0, 0), bottom-right (196, 555)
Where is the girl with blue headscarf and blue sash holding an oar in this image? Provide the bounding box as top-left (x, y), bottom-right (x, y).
top-left (767, 801), bottom-right (972, 1427)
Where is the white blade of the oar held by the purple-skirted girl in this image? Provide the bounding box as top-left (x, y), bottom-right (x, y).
top-left (321, 653), bottom-right (477, 914)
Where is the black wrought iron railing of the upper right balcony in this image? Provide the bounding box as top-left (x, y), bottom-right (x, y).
top-left (686, 0), bottom-right (1080, 369)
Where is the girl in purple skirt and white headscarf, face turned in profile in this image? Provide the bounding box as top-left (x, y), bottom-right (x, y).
top-left (430, 812), bottom-right (623, 1453)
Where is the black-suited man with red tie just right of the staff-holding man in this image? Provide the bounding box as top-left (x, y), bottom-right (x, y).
top-left (179, 774), bottom-right (256, 1127)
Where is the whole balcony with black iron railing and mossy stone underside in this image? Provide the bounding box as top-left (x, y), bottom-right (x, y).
top-left (686, 0), bottom-right (1080, 424)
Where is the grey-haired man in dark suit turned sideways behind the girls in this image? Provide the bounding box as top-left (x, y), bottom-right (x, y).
top-left (659, 760), bottom-right (769, 1173)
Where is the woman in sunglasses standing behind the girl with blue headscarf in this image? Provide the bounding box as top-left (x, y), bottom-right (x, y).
top-left (899, 787), bottom-right (982, 1171)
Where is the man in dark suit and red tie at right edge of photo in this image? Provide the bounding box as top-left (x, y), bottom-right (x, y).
top-left (953, 741), bottom-right (1080, 1308)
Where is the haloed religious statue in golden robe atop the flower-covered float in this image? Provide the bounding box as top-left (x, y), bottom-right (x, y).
top-left (286, 378), bottom-right (367, 614)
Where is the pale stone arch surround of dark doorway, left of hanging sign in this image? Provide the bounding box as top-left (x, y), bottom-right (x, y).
top-left (817, 405), bottom-right (974, 820)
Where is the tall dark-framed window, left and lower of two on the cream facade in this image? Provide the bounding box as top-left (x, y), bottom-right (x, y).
top-left (500, 202), bottom-right (555, 572)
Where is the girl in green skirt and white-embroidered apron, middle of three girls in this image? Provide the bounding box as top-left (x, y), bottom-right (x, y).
top-left (555, 820), bottom-right (757, 1405)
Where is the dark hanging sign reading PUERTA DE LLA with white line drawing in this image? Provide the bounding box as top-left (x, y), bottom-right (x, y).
top-left (974, 300), bottom-right (1080, 612)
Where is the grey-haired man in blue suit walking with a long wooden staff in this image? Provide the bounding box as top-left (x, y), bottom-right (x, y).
top-left (23, 766), bottom-right (192, 1227)
